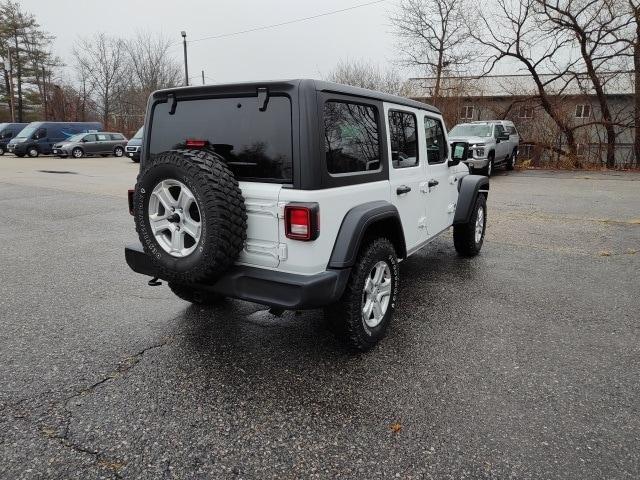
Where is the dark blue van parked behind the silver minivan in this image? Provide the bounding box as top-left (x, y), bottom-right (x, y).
top-left (7, 122), bottom-right (102, 157)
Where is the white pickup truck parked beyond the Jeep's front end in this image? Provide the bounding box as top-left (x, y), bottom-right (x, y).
top-left (449, 120), bottom-right (520, 177)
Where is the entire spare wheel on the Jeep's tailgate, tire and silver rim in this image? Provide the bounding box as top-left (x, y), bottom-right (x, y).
top-left (133, 150), bottom-right (247, 284)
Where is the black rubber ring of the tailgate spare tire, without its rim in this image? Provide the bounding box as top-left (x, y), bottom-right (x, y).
top-left (133, 150), bottom-right (247, 284)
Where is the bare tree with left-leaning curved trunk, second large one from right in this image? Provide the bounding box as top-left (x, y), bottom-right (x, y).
top-left (472, 0), bottom-right (579, 166)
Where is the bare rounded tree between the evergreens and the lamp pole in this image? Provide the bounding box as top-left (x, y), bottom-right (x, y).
top-left (73, 33), bottom-right (126, 128)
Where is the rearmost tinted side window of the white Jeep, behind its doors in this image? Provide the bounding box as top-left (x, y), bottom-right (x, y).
top-left (324, 101), bottom-right (380, 174)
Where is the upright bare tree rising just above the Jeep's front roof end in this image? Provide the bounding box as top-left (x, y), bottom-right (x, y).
top-left (391, 0), bottom-right (473, 104)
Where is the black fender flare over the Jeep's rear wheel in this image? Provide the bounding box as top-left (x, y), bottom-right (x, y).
top-left (328, 200), bottom-right (407, 268)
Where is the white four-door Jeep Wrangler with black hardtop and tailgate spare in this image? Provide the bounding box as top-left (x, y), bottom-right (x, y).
top-left (125, 80), bottom-right (489, 350)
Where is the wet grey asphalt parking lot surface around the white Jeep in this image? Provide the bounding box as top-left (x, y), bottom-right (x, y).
top-left (0, 156), bottom-right (640, 479)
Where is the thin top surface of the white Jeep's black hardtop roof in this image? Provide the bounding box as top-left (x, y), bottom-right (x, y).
top-left (153, 79), bottom-right (440, 114)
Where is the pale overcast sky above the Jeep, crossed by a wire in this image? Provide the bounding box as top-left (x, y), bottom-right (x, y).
top-left (18, 0), bottom-right (408, 83)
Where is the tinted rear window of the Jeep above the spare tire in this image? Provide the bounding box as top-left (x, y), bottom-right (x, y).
top-left (149, 96), bottom-right (292, 183)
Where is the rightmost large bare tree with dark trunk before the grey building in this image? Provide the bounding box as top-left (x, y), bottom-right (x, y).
top-left (537, 0), bottom-right (633, 168)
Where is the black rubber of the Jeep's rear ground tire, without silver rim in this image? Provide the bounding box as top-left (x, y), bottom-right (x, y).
top-left (325, 238), bottom-right (400, 351)
